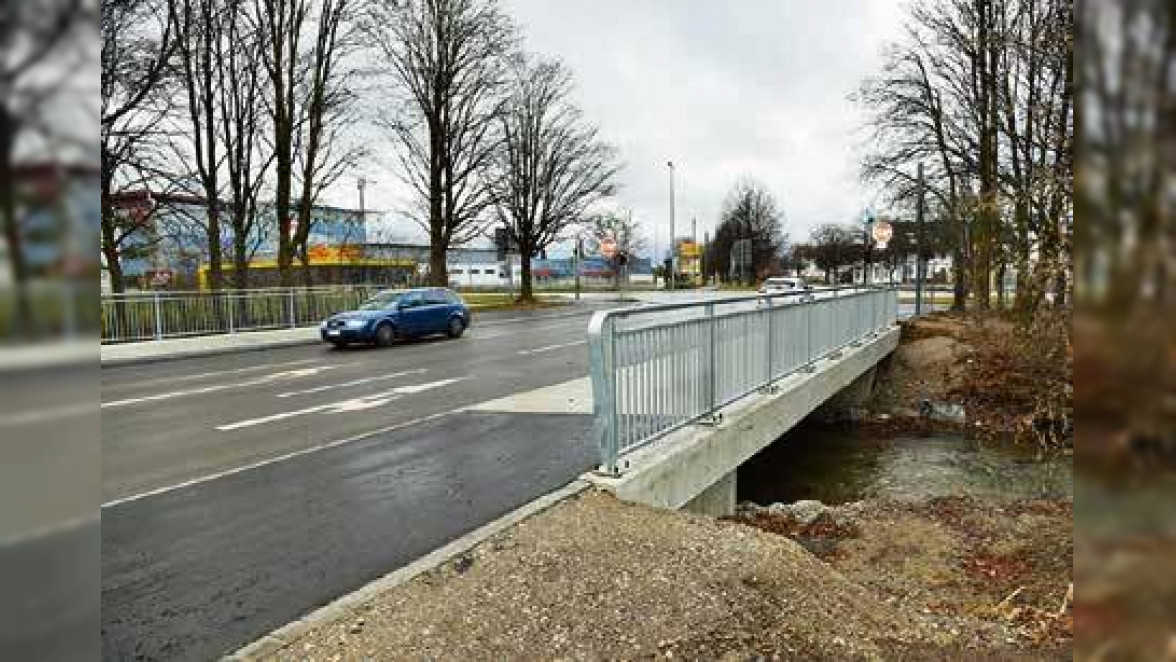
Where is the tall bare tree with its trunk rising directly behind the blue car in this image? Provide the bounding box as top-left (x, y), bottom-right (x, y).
top-left (368, 0), bottom-right (515, 285)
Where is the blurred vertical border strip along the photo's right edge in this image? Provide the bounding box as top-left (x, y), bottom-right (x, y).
top-left (1074, 0), bottom-right (1176, 660)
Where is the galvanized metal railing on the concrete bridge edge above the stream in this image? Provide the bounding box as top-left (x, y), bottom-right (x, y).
top-left (588, 287), bottom-right (897, 475)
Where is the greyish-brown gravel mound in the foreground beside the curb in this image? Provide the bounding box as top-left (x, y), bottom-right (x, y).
top-left (266, 493), bottom-right (948, 660)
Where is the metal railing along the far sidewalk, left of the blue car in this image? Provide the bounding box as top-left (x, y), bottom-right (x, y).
top-left (101, 286), bottom-right (381, 343)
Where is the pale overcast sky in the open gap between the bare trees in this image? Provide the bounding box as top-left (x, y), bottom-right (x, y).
top-left (345, 0), bottom-right (901, 258)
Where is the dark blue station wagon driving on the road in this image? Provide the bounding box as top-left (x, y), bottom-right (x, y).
top-left (319, 288), bottom-right (470, 347)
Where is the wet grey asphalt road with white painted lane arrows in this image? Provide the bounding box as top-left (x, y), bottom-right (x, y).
top-left (101, 309), bottom-right (595, 660)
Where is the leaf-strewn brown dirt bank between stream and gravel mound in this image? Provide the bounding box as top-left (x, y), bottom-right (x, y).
top-left (741, 497), bottom-right (1074, 660)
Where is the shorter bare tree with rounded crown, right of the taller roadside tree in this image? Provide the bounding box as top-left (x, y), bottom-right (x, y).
top-left (490, 56), bottom-right (619, 301)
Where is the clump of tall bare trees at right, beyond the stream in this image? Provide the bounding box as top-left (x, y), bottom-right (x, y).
top-left (858, 0), bottom-right (1074, 309)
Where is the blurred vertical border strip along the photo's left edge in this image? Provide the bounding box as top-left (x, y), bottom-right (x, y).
top-left (0, 0), bottom-right (101, 660)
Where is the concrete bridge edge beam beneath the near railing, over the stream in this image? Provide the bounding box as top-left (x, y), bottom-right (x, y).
top-left (586, 327), bottom-right (898, 515)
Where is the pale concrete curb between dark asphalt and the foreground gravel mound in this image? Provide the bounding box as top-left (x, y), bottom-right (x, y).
top-left (221, 479), bottom-right (592, 662)
